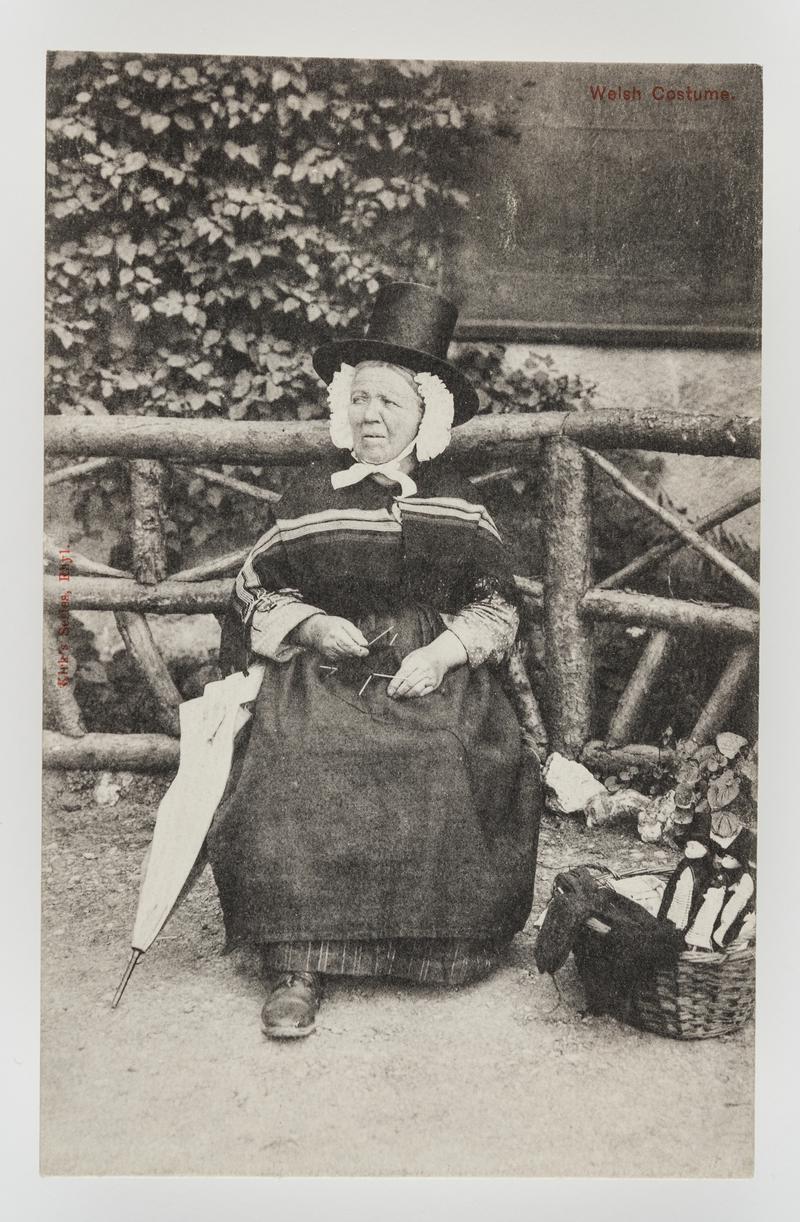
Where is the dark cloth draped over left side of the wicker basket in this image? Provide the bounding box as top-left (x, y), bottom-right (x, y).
top-left (534, 866), bottom-right (684, 1012)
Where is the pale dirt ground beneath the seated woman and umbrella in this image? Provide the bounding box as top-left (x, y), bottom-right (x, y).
top-left (42, 774), bottom-right (752, 1177)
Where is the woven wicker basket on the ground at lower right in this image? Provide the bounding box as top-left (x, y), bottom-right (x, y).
top-left (574, 871), bottom-right (756, 1040)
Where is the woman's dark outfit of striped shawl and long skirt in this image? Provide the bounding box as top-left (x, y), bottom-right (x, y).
top-left (209, 459), bottom-right (540, 981)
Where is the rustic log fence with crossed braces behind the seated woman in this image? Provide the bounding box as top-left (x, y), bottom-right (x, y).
top-left (44, 411), bottom-right (760, 771)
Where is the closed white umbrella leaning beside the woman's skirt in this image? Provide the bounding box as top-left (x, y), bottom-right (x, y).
top-left (111, 664), bottom-right (264, 1009)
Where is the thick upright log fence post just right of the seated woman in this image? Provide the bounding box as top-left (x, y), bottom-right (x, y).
top-left (542, 437), bottom-right (594, 759)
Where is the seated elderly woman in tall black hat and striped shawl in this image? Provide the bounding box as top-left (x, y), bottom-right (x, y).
top-left (208, 284), bottom-right (540, 1037)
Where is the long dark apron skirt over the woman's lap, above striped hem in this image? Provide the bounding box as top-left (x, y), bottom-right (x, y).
top-left (208, 606), bottom-right (541, 953)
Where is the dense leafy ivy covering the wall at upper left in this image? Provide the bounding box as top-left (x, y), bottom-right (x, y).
top-left (46, 53), bottom-right (492, 419)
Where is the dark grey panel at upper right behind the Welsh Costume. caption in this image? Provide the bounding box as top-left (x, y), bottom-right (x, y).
top-left (446, 64), bottom-right (761, 326)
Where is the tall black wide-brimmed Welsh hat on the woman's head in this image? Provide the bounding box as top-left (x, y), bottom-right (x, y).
top-left (311, 282), bottom-right (479, 424)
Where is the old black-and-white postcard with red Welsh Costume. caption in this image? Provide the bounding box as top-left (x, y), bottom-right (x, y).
top-left (39, 35), bottom-right (763, 1179)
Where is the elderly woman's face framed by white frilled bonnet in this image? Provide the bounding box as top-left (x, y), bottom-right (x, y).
top-left (348, 365), bottom-right (424, 463)
